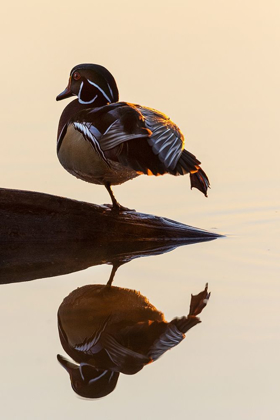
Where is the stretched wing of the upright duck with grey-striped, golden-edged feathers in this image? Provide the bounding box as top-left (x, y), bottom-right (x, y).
top-left (100, 103), bottom-right (207, 180)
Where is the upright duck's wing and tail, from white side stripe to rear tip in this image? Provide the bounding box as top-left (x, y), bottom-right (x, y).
top-left (73, 102), bottom-right (209, 195)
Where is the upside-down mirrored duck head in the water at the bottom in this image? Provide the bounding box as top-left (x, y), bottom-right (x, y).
top-left (57, 354), bottom-right (119, 398)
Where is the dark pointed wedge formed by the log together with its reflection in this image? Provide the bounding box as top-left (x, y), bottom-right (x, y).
top-left (0, 189), bottom-right (223, 284)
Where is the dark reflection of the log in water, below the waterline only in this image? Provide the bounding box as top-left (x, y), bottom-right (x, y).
top-left (0, 238), bottom-right (215, 284)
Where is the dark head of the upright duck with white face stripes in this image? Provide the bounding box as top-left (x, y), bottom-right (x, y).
top-left (56, 64), bottom-right (119, 106)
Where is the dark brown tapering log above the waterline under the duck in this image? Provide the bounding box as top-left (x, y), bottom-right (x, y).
top-left (0, 188), bottom-right (221, 243)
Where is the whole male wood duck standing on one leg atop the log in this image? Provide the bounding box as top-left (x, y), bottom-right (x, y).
top-left (56, 64), bottom-right (209, 210)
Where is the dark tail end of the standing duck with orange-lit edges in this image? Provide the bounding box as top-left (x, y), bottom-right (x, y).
top-left (175, 150), bottom-right (210, 197)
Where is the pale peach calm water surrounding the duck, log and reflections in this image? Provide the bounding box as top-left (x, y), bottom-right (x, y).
top-left (0, 1), bottom-right (280, 420)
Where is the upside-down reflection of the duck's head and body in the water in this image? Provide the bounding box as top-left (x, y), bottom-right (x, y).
top-left (57, 281), bottom-right (210, 398)
